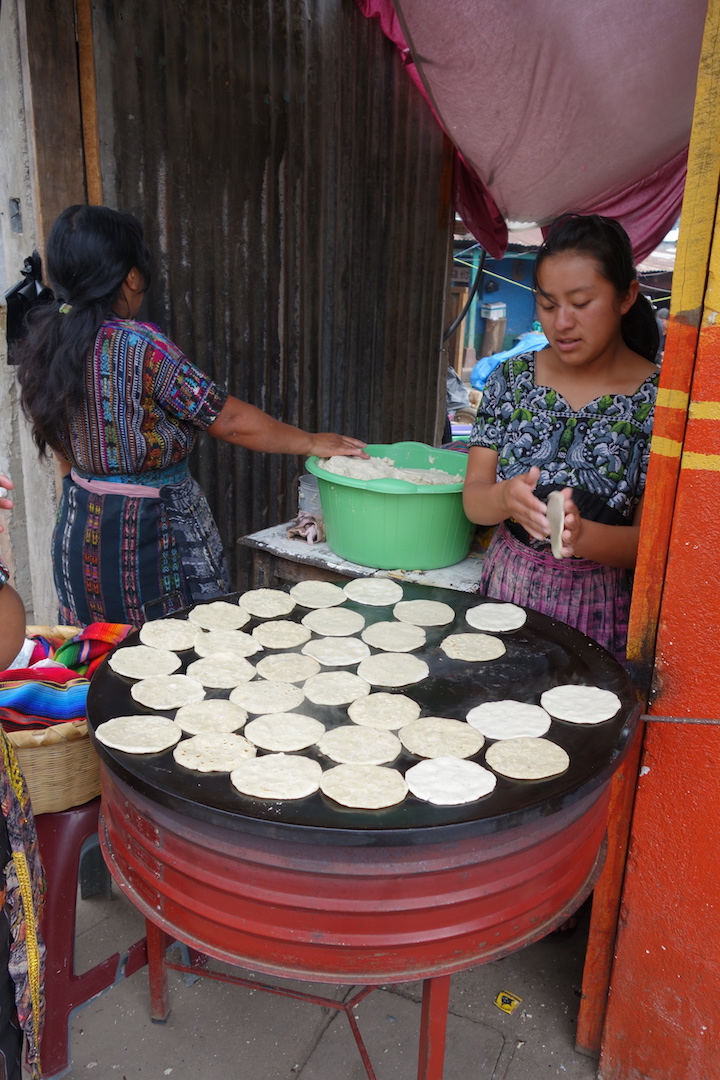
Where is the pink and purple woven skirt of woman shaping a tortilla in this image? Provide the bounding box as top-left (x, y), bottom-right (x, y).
top-left (477, 523), bottom-right (630, 664)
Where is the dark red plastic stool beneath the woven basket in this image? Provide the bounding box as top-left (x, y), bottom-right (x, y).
top-left (36, 798), bottom-right (148, 1078)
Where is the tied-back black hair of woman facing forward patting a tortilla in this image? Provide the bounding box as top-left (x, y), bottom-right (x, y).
top-left (533, 214), bottom-right (660, 363)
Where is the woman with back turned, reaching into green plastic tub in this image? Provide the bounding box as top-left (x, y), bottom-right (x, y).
top-left (15, 206), bottom-right (365, 625)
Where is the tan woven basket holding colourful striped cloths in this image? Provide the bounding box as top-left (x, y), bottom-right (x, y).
top-left (6, 720), bottom-right (100, 814)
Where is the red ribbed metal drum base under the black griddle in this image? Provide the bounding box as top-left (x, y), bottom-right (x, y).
top-left (100, 769), bottom-right (609, 985)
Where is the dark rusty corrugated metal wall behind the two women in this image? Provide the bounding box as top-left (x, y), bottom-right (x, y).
top-left (93, 0), bottom-right (449, 583)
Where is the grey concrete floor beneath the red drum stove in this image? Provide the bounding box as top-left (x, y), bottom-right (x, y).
top-left (40, 887), bottom-right (597, 1080)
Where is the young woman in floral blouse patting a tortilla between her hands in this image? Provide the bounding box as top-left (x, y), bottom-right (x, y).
top-left (464, 214), bottom-right (658, 661)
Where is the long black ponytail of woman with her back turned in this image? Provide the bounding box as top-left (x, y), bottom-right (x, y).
top-left (13, 206), bottom-right (150, 455)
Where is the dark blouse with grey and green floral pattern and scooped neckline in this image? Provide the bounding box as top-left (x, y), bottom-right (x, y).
top-left (470, 353), bottom-right (658, 525)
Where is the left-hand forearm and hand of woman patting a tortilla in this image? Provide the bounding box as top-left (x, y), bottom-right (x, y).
top-left (463, 446), bottom-right (549, 540)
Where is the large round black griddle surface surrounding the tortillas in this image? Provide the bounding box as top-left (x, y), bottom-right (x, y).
top-left (87, 583), bottom-right (639, 845)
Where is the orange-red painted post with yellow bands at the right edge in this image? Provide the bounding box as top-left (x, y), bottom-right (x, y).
top-left (599, 0), bottom-right (720, 1080)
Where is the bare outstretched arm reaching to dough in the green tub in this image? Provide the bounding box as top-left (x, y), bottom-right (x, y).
top-left (207, 397), bottom-right (367, 458)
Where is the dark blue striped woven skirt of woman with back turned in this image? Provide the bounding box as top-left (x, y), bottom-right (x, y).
top-left (53, 471), bottom-right (230, 626)
